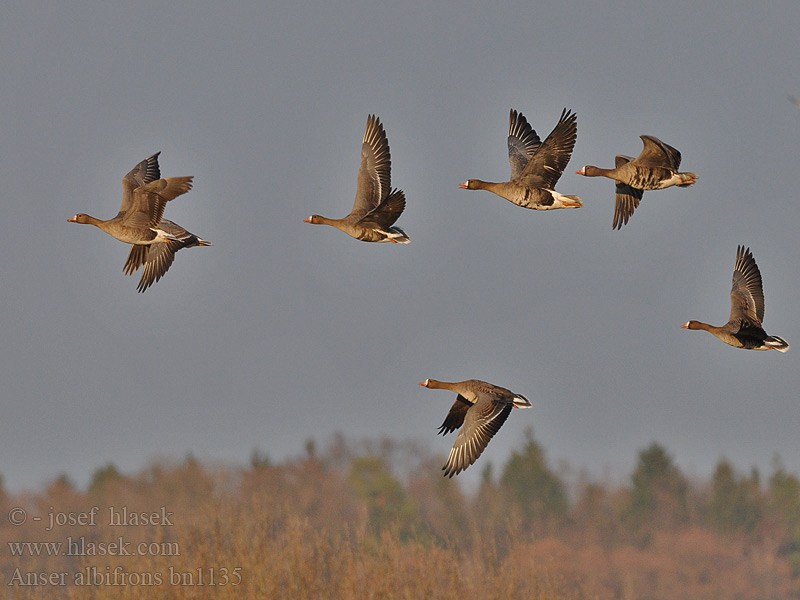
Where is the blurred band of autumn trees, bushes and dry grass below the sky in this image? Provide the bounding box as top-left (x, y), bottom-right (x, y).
top-left (0, 432), bottom-right (800, 600)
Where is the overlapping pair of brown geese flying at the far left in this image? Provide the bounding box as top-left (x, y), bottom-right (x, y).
top-left (69, 152), bottom-right (211, 292)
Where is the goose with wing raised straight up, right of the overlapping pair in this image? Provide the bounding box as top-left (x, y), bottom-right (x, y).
top-left (305, 115), bottom-right (410, 244)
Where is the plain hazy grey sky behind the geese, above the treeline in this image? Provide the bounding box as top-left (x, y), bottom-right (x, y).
top-left (0, 0), bottom-right (800, 489)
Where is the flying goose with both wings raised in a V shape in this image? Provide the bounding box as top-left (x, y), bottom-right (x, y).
top-left (458, 108), bottom-right (583, 210)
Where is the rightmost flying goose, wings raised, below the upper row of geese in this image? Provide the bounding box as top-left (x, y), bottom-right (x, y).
top-left (681, 246), bottom-right (789, 352)
